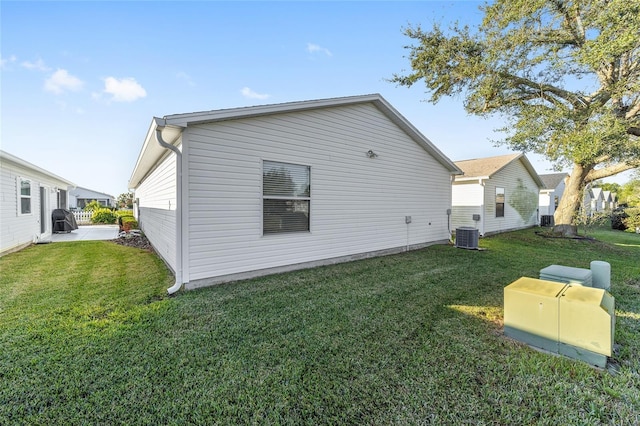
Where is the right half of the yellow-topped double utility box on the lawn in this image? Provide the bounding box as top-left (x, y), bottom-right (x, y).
top-left (558, 286), bottom-right (616, 367)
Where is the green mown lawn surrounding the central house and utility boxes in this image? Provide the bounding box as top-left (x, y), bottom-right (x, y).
top-left (0, 229), bottom-right (640, 425)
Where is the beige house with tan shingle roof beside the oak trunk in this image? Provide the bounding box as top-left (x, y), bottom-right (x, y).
top-left (451, 154), bottom-right (544, 235)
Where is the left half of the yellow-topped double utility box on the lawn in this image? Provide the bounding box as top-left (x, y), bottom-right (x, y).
top-left (504, 277), bottom-right (568, 352)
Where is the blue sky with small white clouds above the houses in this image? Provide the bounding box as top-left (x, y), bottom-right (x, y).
top-left (0, 1), bottom-right (625, 196)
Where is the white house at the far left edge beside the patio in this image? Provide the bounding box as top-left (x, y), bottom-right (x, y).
top-left (0, 151), bottom-right (75, 255)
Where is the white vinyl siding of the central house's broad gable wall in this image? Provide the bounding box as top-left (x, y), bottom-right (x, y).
top-left (185, 104), bottom-right (451, 280)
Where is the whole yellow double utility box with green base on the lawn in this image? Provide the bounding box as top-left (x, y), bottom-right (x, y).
top-left (504, 277), bottom-right (615, 367)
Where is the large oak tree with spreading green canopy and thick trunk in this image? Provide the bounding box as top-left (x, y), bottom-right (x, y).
top-left (391, 0), bottom-right (640, 235)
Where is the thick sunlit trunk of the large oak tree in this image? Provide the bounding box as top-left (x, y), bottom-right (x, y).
top-left (553, 164), bottom-right (592, 237)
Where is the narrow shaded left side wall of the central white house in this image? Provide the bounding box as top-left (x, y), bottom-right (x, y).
top-left (135, 151), bottom-right (177, 271)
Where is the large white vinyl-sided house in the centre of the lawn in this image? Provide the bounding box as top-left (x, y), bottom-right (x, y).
top-left (129, 94), bottom-right (460, 293)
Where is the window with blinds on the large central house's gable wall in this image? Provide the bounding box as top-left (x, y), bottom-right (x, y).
top-left (262, 161), bottom-right (311, 235)
